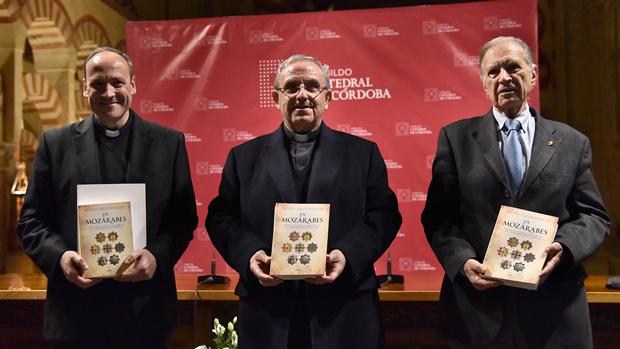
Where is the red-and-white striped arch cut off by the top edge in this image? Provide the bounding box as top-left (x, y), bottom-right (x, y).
top-left (20, 0), bottom-right (73, 50)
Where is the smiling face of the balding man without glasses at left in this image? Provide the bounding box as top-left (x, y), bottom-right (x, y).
top-left (83, 51), bottom-right (136, 129)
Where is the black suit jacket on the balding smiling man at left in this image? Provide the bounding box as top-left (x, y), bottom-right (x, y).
top-left (17, 111), bottom-right (198, 339)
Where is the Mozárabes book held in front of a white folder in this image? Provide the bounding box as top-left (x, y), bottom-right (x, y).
top-left (78, 201), bottom-right (133, 278)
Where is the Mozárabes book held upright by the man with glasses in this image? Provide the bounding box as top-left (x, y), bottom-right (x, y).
top-left (269, 203), bottom-right (330, 280)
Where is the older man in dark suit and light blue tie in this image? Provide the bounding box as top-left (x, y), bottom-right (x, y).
top-left (422, 37), bottom-right (610, 348)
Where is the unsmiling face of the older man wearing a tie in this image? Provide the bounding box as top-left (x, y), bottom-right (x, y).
top-left (480, 40), bottom-right (538, 118)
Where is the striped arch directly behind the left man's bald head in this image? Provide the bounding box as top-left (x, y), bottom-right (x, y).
top-left (72, 15), bottom-right (110, 83)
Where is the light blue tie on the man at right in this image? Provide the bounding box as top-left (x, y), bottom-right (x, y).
top-left (502, 119), bottom-right (525, 197)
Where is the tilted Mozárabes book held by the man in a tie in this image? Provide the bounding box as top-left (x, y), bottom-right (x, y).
top-left (482, 205), bottom-right (558, 290)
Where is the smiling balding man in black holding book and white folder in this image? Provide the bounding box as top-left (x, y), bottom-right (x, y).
top-left (17, 48), bottom-right (198, 348)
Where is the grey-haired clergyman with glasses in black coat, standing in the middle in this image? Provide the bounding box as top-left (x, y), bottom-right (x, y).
top-left (206, 55), bottom-right (401, 349)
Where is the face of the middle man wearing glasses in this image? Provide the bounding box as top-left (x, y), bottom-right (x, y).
top-left (271, 61), bottom-right (332, 134)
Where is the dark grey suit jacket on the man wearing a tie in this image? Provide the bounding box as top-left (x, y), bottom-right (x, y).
top-left (422, 109), bottom-right (610, 348)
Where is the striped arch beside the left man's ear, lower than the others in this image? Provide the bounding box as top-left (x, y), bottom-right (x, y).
top-left (23, 73), bottom-right (63, 136)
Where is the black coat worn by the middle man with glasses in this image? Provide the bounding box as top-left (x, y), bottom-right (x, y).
top-left (206, 125), bottom-right (401, 348)
